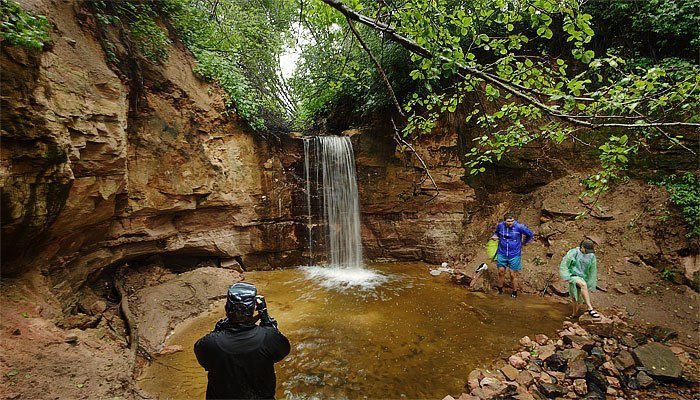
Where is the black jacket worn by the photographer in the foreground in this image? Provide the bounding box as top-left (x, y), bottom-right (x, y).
top-left (194, 320), bottom-right (290, 399)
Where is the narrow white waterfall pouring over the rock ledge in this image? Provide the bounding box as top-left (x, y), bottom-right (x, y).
top-left (304, 136), bottom-right (363, 269)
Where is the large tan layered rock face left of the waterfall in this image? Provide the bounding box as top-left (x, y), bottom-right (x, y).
top-left (0, 0), bottom-right (304, 304)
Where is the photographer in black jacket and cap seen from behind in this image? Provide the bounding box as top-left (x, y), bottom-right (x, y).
top-left (194, 282), bottom-right (290, 399)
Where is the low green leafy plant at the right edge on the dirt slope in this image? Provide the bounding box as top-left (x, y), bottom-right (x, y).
top-left (657, 172), bottom-right (700, 237)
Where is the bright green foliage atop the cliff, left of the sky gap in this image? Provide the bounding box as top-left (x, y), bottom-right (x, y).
top-left (161, 0), bottom-right (296, 133)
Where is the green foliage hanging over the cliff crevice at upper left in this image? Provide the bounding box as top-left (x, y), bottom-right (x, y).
top-left (93, 1), bottom-right (171, 63)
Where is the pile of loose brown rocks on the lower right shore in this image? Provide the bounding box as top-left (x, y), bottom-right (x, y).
top-left (443, 315), bottom-right (700, 400)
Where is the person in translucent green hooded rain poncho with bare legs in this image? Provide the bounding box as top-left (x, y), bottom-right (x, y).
top-left (559, 239), bottom-right (601, 319)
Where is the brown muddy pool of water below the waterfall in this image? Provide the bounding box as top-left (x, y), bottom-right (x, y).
top-left (140, 263), bottom-right (568, 399)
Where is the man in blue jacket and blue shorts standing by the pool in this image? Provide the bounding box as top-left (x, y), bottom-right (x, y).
top-left (491, 213), bottom-right (535, 297)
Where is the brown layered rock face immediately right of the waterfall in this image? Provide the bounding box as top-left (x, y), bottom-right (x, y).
top-left (352, 123), bottom-right (477, 262)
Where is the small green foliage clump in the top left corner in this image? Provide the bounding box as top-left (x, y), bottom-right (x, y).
top-left (0, 0), bottom-right (51, 51)
